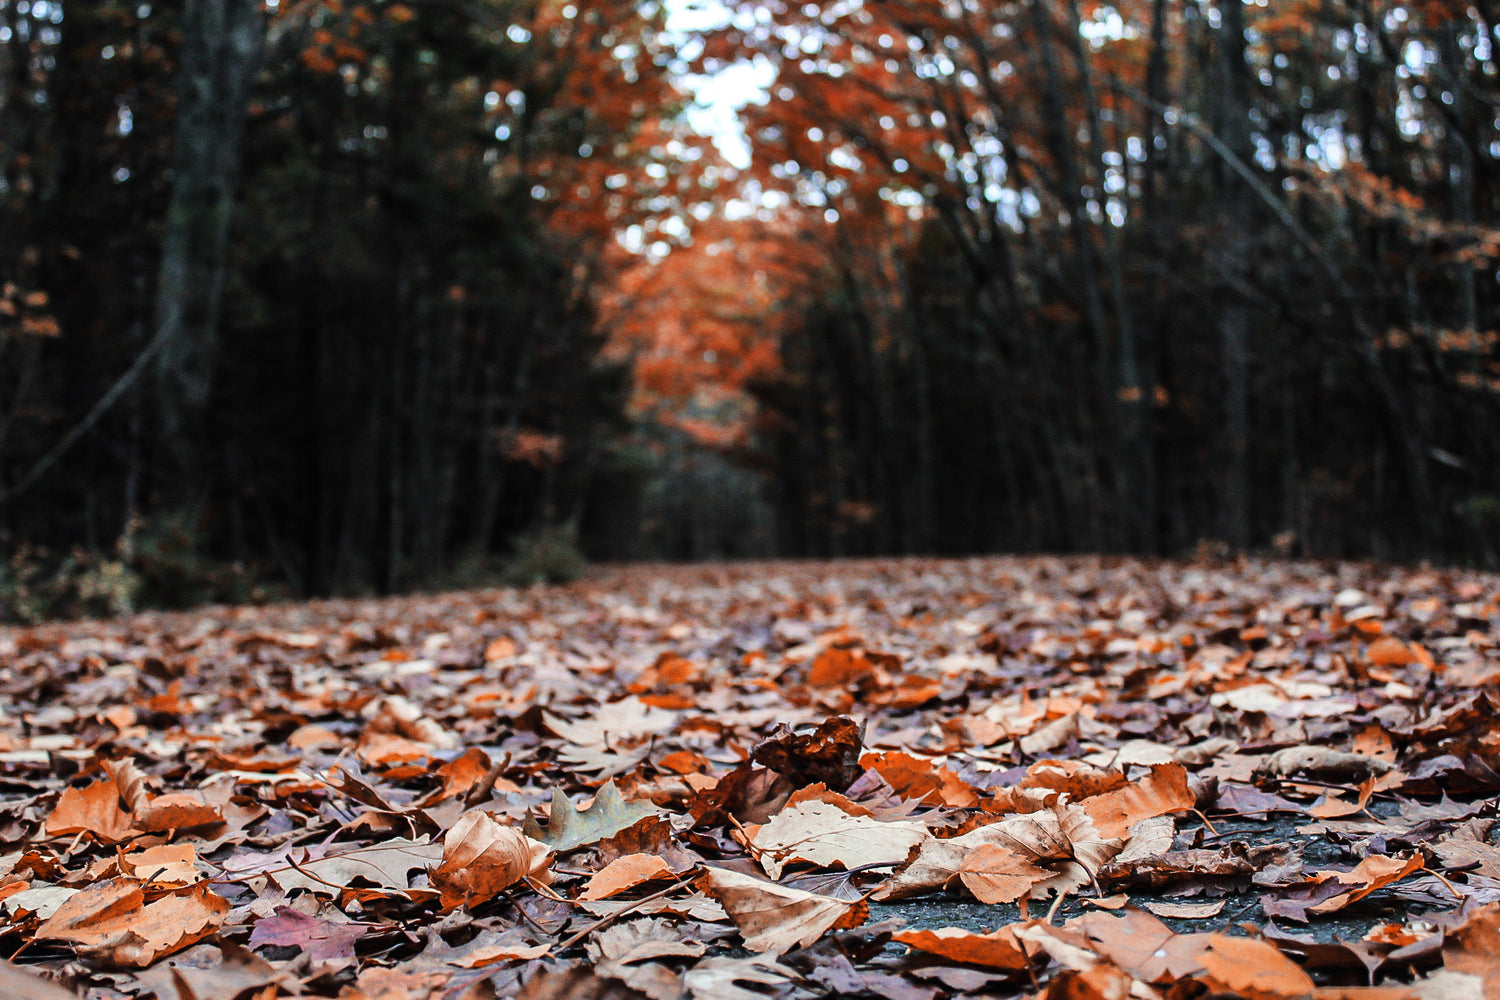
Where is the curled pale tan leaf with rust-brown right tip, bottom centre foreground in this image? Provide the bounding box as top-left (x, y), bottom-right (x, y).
top-left (701, 867), bottom-right (870, 955)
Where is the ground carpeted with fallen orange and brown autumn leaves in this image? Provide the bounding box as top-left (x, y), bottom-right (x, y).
top-left (0, 558), bottom-right (1500, 1000)
